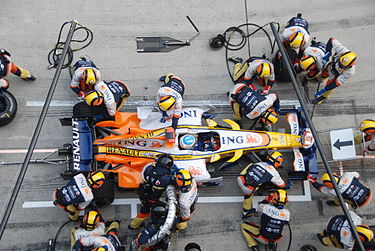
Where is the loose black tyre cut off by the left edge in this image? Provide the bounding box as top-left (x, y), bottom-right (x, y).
top-left (0, 91), bottom-right (17, 126)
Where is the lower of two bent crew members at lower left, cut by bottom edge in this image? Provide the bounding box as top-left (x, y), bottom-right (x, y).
top-left (72, 221), bottom-right (123, 251)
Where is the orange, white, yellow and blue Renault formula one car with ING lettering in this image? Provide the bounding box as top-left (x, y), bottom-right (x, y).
top-left (61, 104), bottom-right (315, 188)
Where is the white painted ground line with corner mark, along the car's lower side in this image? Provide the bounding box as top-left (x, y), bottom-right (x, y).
top-left (22, 180), bottom-right (311, 218)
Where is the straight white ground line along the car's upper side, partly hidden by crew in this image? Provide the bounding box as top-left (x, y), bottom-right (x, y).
top-left (26, 100), bottom-right (299, 107)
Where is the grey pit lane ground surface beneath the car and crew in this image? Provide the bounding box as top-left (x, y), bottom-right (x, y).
top-left (0, 0), bottom-right (375, 251)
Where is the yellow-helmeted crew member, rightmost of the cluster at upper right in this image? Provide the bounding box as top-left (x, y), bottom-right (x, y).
top-left (313, 38), bottom-right (357, 104)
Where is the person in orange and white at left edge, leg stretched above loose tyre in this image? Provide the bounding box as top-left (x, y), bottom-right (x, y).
top-left (0, 49), bottom-right (36, 91)
